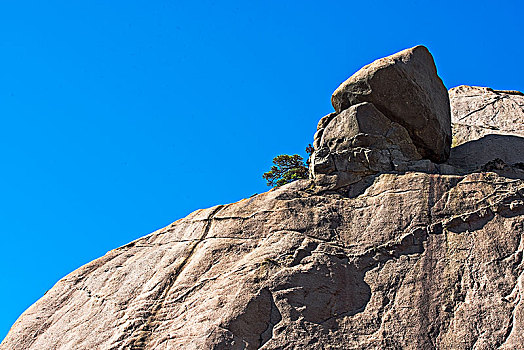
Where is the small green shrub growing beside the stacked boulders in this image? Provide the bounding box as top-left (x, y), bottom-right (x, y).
top-left (262, 154), bottom-right (308, 187)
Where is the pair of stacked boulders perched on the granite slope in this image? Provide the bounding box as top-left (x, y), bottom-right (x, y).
top-left (310, 46), bottom-right (451, 190)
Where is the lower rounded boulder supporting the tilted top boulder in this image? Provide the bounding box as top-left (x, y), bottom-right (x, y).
top-left (310, 102), bottom-right (421, 190)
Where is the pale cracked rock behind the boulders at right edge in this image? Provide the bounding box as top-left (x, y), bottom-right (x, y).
top-left (448, 85), bottom-right (524, 172)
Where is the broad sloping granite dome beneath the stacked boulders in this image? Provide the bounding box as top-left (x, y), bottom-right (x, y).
top-left (0, 173), bottom-right (524, 350)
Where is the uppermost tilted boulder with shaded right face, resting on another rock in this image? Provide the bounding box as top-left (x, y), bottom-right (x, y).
top-left (331, 46), bottom-right (451, 163)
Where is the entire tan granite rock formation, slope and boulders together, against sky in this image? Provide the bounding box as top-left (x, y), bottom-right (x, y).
top-left (0, 47), bottom-right (524, 350)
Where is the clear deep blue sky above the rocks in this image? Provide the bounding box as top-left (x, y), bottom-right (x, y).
top-left (0, 0), bottom-right (524, 339)
